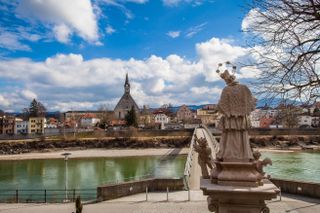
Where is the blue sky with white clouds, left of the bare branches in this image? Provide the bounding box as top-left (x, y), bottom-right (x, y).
top-left (0, 0), bottom-right (258, 112)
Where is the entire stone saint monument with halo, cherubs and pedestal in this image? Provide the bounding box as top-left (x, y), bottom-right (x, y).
top-left (199, 62), bottom-right (279, 213)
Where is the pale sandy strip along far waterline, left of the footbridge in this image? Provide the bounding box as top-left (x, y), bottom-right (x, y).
top-left (0, 148), bottom-right (189, 160)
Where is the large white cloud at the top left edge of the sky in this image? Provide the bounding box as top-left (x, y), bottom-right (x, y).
top-left (17, 0), bottom-right (99, 43)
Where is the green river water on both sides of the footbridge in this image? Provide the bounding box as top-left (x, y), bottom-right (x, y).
top-left (0, 152), bottom-right (320, 202)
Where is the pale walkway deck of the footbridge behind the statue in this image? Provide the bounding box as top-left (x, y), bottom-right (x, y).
top-left (189, 128), bottom-right (215, 190)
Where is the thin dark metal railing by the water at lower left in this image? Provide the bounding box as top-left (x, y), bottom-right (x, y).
top-left (0, 188), bottom-right (97, 203)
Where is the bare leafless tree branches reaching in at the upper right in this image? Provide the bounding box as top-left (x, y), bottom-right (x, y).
top-left (242, 0), bottom-right (320, 103)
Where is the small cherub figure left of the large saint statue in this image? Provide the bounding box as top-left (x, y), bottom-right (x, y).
top-left (193, 135), bottom-right (213, 178)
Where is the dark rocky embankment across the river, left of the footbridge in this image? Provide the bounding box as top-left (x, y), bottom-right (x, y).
top-left (0, 136), bottom-right (191, 155)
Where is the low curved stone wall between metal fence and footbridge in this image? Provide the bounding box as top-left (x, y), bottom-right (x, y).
top-left (97, 178), bottom-right (184, 201)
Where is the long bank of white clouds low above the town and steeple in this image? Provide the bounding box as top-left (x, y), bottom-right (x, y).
top-left (0, 38), bottom-right (256, 110)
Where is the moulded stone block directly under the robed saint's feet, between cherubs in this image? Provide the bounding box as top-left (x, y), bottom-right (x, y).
top-left (211, 161), bottom-right (263, 187)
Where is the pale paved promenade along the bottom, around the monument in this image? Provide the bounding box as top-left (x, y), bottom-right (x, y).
top-left (0, 191), bottom-right (320, 213)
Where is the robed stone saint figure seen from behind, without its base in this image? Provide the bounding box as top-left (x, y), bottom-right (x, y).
top-left (217, 70), bottom-right (256, 162)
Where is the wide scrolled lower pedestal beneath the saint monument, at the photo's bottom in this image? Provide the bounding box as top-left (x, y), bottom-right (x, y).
top-left (200, 178), bottom-right (279, 213)
